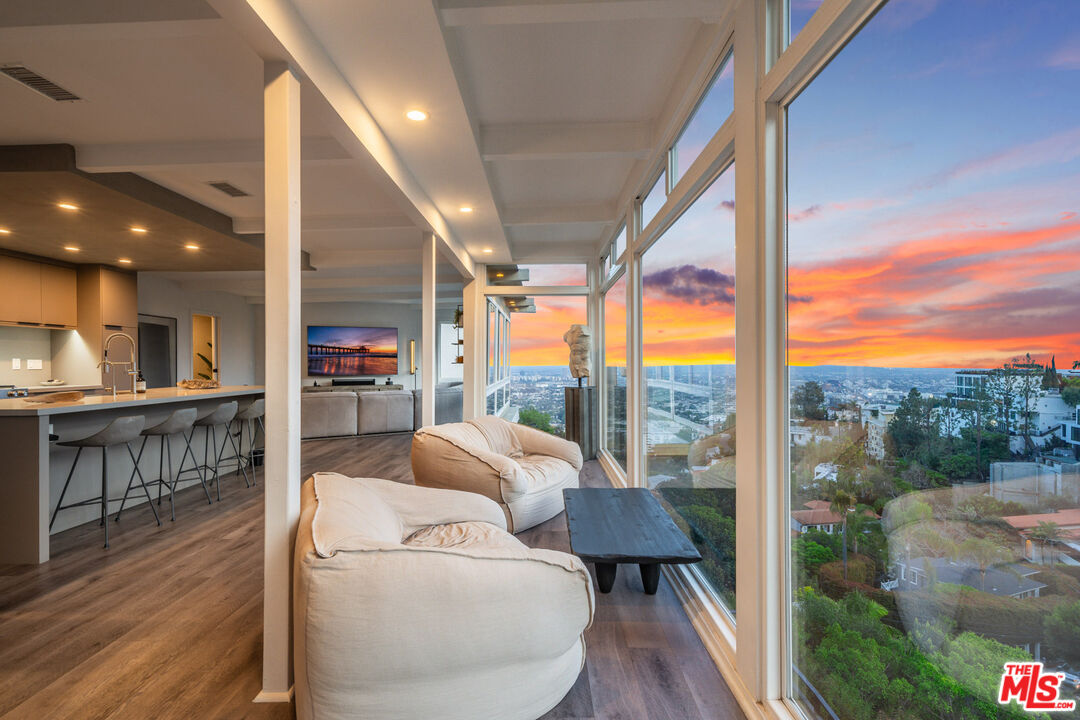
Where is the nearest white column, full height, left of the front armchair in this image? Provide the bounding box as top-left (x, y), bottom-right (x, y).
top-left (255, 63), bottom-right (300, 703)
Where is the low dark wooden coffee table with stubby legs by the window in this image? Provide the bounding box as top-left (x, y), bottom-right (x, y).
top-left (563, 488), bottom-right (701, 595)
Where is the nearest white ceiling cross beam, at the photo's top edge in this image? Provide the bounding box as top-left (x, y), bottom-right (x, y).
top-left (440, 0), bottom-right (727, 27)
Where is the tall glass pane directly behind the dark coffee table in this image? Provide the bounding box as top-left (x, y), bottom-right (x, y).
top-left (642, 168), bottom-right (735, 613)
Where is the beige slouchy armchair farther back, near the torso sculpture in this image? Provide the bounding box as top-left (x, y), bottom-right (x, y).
top-left (413, 416), bottom-right (582, 532)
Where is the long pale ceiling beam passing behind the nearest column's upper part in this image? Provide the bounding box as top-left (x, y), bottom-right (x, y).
top-left (76, 137), bottom-right (355, 173)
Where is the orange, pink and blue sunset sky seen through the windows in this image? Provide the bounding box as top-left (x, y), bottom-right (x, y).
top-left (512, 0), bottom-right (1080, 367)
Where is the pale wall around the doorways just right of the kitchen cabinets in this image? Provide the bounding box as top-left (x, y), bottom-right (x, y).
top-left (138, 273), bottom-right (262, 385)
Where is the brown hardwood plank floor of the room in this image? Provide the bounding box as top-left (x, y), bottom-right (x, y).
top-left (0, 435), bottom-right (743, 720)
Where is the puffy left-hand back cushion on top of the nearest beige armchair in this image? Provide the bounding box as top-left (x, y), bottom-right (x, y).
top-left (311, 473), bottom-right (403, 557)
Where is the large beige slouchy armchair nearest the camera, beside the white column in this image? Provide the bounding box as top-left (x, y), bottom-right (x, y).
top-left (293, 473), bottom-right (594, 720)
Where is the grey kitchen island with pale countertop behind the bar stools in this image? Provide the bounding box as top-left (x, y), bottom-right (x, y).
top-left (0, 385), bottom-right (262, 563)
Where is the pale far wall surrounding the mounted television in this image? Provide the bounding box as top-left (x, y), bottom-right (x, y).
top-left (254, 302), bottom-right (454, 390)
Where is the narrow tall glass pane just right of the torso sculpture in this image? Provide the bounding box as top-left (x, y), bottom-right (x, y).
top-left (604, 273), bottom-right (626, 470)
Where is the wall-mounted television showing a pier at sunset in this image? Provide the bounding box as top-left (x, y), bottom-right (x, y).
top-left (308, 325), bottom-right (397, 378)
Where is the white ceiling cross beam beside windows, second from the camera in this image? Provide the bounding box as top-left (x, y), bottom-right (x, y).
top-left (480, 122), bottom-right (651, 161)
